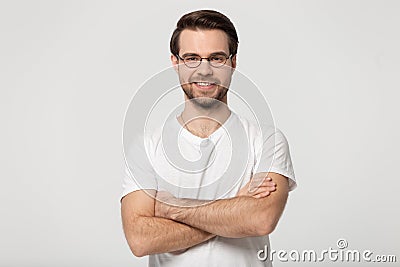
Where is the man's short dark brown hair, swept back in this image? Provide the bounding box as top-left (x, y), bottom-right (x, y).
top-left (169, 10), bottom-right (239, 56)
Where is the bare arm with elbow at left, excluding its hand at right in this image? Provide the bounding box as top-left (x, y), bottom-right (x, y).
top-left (121, 190), bottom-right (215, 257)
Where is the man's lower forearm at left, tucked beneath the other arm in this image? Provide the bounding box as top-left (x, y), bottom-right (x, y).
top-left (127, 216), bottom-right (214, 256)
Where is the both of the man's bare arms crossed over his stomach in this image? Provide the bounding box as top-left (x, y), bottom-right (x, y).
top-left (121, 172), bottom-right (289, 257)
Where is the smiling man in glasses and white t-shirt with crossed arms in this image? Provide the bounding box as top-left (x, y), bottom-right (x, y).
top-left (121, 10), bottom-right (296, 267)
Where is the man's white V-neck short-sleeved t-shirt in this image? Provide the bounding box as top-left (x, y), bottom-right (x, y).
top-left (121, 112), bottom-right (296, 267)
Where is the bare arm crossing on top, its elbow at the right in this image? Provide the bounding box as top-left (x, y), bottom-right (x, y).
top-left (156, 173), bottom-right (289, 238)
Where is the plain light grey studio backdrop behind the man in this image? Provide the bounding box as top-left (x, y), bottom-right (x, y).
top-left (0, 0), bottom-right (400, 267)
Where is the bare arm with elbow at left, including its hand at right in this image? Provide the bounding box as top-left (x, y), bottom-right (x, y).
top-left (121, 174), bottom-right (276, 257)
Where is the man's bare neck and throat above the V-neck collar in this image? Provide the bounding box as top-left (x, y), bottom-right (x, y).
top-left (180, 101), bottom-right (231, 138)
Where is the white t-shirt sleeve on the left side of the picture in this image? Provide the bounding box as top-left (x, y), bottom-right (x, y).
top-left (120, 137), bottom-right (158, 200)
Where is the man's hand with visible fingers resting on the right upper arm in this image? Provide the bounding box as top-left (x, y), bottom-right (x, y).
top-left (236, 173), bottom-right (276, 198)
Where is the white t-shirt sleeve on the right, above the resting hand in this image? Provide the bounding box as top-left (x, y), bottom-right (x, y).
top-left (255, 129), bottom-right (297, 191)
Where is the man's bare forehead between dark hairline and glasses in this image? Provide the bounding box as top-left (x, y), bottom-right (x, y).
top-left (179, 29), bottom-right (229, 56)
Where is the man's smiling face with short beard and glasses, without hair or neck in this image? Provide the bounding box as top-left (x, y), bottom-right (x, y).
top-left (171, 29), bottom-right (236, 108)
